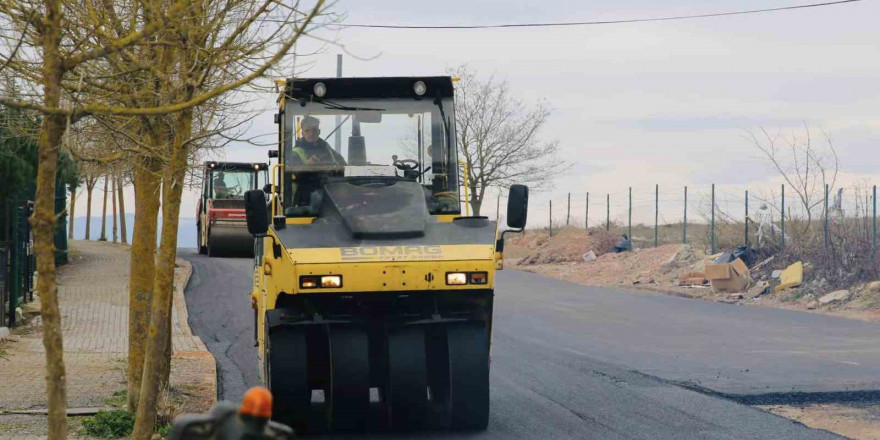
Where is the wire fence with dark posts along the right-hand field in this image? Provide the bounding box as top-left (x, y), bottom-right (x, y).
top-left (524, 185), bottom-right (878, 256)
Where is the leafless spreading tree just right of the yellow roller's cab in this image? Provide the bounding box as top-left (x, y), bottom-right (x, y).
top-left (452, 66), bottom-right (568, 215)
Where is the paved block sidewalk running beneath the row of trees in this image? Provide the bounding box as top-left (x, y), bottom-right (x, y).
top-left (0, 241), bottom-right (216, 440)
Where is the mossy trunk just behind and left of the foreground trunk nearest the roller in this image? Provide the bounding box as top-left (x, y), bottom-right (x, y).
top-left (128, 159), bottom-right (161, 413)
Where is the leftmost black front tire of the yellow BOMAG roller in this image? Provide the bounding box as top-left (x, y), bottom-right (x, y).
top-left (264, 327), bottom-right (312, 433)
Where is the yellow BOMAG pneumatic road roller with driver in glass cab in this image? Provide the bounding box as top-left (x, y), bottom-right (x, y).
top-left (245, 77), bottom-right (528, 433)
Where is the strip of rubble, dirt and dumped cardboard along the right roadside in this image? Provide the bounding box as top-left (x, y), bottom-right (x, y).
top-left (505, 228), bottom-right (880, 310)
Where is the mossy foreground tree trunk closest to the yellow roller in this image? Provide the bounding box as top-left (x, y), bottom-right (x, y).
top-left (131, 109), bottom-right (193, 440)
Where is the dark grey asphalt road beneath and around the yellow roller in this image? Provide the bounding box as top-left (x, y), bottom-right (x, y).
top-left (181, 251), bottom-right (880, 439)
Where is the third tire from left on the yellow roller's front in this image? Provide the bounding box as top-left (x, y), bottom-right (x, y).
top-left (385, 326), bottom-right (428, 430)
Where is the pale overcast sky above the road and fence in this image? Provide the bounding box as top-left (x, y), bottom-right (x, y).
top-left (75, 0), bottom-right (880, 227)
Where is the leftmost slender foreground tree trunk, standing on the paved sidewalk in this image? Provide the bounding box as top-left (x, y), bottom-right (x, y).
top-left (31, 0), bottom-right (67, 440)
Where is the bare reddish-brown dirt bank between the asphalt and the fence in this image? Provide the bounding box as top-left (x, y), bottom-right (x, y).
top-left (505, 228), bottom-right (880, 320)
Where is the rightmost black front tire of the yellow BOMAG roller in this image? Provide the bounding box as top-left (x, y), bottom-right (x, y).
top-left (447, 322), bottom-right (489, 430)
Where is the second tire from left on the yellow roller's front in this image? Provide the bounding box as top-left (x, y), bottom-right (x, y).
top-left (329, 326), bottom-right (370, 432)
